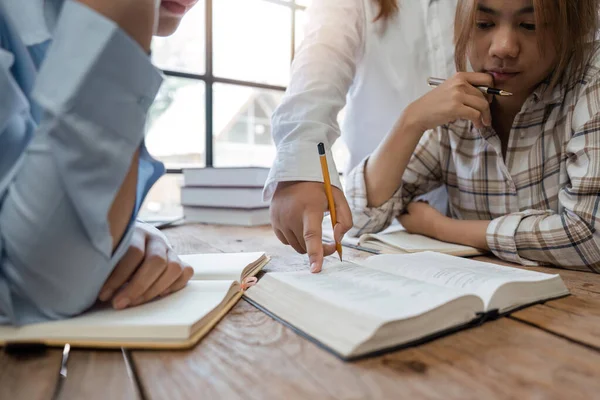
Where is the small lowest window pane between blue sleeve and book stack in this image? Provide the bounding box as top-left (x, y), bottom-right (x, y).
top-left (138, 174), bottom-right (183, 221)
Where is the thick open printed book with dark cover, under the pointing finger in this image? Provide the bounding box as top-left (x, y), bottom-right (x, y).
top-left (245, 252), bottom-right (569, 360)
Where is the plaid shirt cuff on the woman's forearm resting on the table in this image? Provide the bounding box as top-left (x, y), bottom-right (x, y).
top-left (486, 210), bottom-right (547, 266)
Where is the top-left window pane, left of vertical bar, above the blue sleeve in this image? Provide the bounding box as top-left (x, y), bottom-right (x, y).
top-left (152, 0), bottom-right (205, 74)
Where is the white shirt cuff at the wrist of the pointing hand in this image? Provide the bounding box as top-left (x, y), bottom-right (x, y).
top-left (263, 143), bottom-right (343, 202)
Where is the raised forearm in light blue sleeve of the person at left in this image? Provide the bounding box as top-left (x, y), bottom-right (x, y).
top-left (34, 2), bottom-right (162, 252)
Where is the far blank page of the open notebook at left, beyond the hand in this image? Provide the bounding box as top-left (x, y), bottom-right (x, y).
top-left (179, 252), bottom-right (264, 282)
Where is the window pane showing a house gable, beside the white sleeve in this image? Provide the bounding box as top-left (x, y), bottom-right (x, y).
top-left (213, 84), bottom-right (283, 167)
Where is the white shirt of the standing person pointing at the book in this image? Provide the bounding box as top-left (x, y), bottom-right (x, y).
top-left (264, 0), bottom-right (456, 200)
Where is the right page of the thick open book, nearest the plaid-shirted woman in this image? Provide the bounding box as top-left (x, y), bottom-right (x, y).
top-left (362, 252), bottom-right (555, 305)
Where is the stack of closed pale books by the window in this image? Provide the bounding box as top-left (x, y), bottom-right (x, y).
top-left (181, 167), bottom-right (270, 226)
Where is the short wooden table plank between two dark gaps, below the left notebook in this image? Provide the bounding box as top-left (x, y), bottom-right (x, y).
top-left (58, 350), bottom-right (139, 400)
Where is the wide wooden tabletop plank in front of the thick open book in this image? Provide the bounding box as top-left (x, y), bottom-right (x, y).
top-left (133, 302), bottom-right (600, 399)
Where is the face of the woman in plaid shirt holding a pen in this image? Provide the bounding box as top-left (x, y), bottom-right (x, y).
top-left (468, 0), bottom-right (557, 101)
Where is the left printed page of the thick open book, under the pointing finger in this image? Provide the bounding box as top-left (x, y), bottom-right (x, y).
top-left (268, 262), bottom-right (483, 321)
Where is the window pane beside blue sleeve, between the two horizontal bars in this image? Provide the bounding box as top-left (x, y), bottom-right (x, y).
top-left (146, 77), bottom-right (206, 168)
